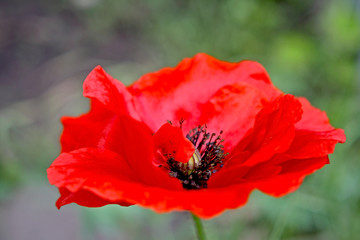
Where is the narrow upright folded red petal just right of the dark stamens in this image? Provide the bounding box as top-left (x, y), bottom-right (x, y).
top-left (226, 95), bottom-right (302, 168)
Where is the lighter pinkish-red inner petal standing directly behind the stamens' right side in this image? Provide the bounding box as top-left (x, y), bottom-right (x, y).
top-left (200, 83), bottom-right (268, 152)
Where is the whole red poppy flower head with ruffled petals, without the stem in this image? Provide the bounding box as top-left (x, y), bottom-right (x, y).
top-left (47, 54), bottom-right (345, 218)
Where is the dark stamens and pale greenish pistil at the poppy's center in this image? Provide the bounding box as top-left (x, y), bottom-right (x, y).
top-left (167, 124), bottom-right (227, 189)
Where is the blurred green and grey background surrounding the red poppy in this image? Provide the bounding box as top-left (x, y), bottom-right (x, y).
top-left (0, 0), bottom-right (360, 240)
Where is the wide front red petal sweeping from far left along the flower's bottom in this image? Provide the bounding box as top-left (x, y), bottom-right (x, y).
top-left (47, 148), bottom-right (253, 218)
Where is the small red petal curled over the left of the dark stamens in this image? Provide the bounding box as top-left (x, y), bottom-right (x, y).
top-left (153, 123), bottom-right (195, 163)
